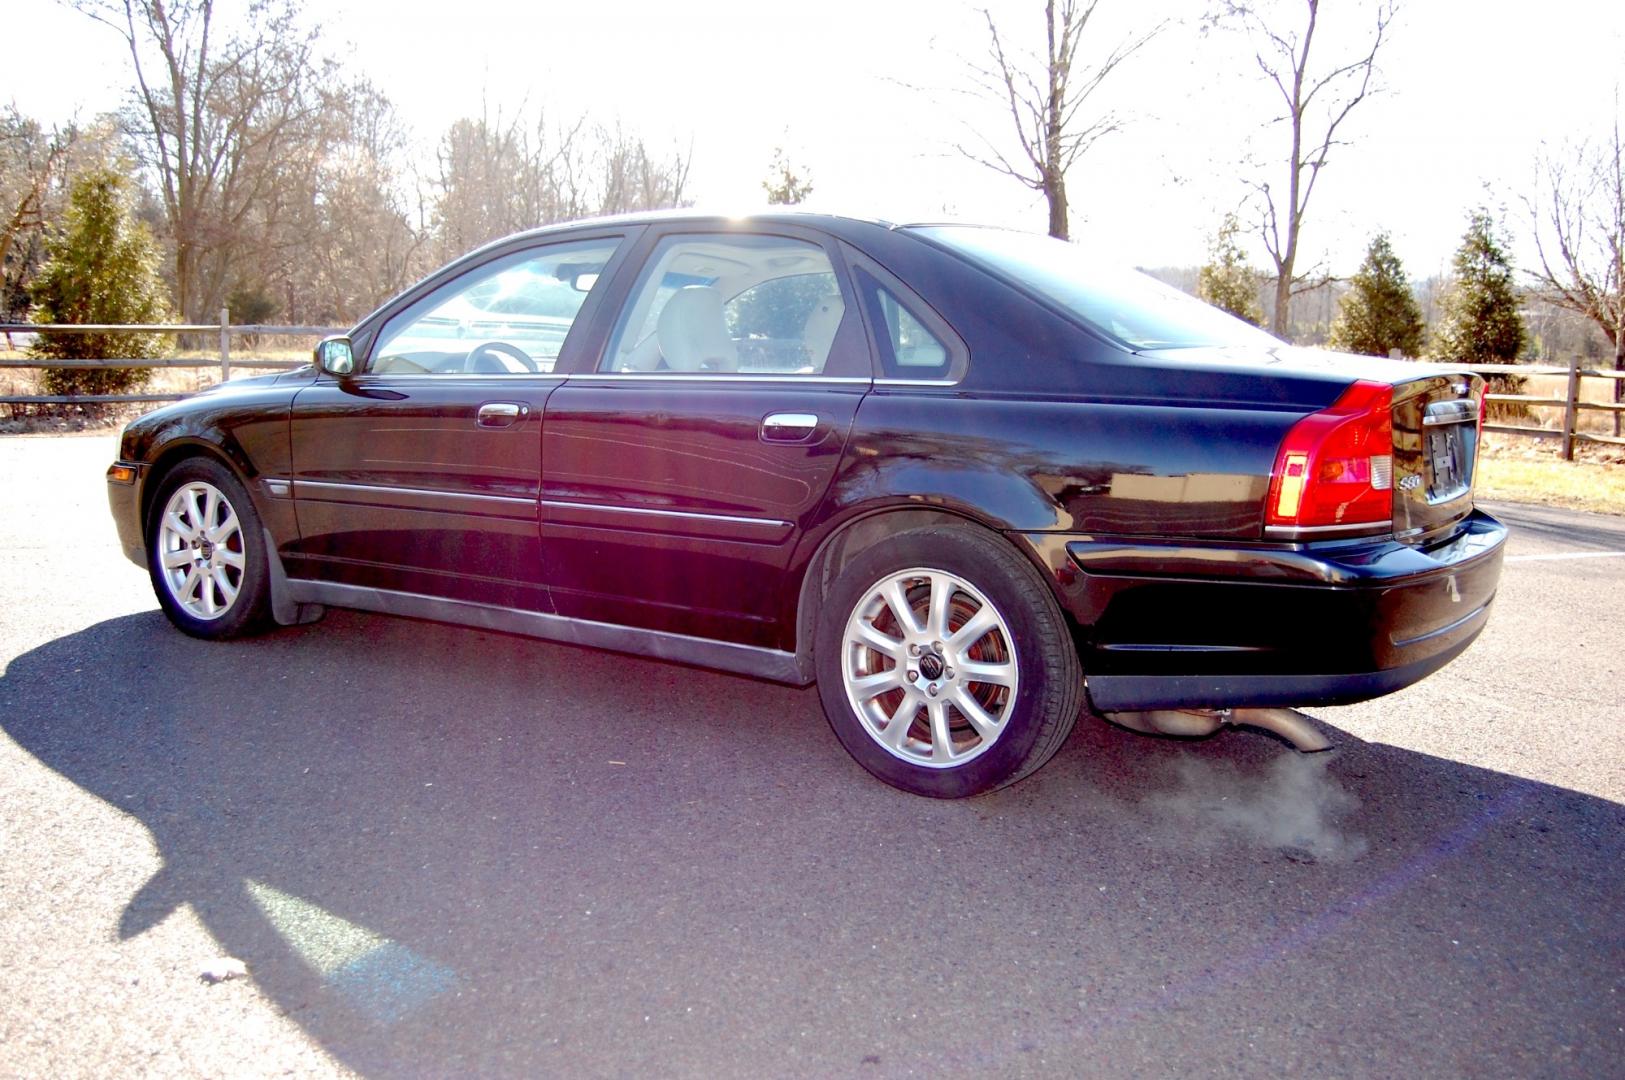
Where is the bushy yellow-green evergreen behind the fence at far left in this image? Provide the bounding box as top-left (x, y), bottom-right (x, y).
top-left (29, 167), bottom-right (169, 395)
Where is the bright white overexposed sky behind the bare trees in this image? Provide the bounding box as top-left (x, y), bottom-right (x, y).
top-left (0, 0), bottom-right (1625, 278)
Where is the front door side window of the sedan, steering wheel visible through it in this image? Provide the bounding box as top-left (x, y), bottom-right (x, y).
top-left (367, 239), bottom-right (619, 375)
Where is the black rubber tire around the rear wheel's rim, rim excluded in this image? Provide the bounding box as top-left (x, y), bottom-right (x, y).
top-left (816, 528), bottom-right (1073, 799)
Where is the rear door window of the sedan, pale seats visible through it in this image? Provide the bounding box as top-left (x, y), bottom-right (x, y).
top-left (600, 235), bottom-right (845, 375)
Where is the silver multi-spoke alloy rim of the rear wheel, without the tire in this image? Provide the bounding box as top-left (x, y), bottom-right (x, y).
top-left (840, 567), bottom-right (1021, 768)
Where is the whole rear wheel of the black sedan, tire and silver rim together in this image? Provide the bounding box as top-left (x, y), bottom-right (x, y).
top-left (814, 526), bottom-right (1084, 799)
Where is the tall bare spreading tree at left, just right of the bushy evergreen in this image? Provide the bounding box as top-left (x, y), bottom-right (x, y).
top-left (73, 0), bottom-right (320, 322)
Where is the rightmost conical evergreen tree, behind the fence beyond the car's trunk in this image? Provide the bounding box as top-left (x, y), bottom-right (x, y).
top-left (1432, 208), bottom-right (1524, 364)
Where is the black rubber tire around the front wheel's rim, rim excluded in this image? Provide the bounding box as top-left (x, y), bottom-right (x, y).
top-left (146, 458), bottom-right (270, 640)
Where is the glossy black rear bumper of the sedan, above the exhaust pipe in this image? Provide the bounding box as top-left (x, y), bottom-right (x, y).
top-left (1027, 512), bottom-right (1506, 711)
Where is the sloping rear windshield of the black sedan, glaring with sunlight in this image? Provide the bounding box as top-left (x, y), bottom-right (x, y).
top-left (915, 226), bottom-right (1281, 349)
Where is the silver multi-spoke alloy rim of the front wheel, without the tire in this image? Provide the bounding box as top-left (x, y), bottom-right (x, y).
top-left (158, 481), bottom-right (247, 622)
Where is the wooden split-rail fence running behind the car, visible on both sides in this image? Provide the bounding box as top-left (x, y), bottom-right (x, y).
top-left (0, 309), bottom-right (1625, 460)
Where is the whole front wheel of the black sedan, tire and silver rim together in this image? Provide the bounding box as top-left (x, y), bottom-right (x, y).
top-left (146, 458), bottom-right (270, 640)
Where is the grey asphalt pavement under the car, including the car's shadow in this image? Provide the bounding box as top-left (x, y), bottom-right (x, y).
top-left (0, 437), bottom-right (1625, 1077)
